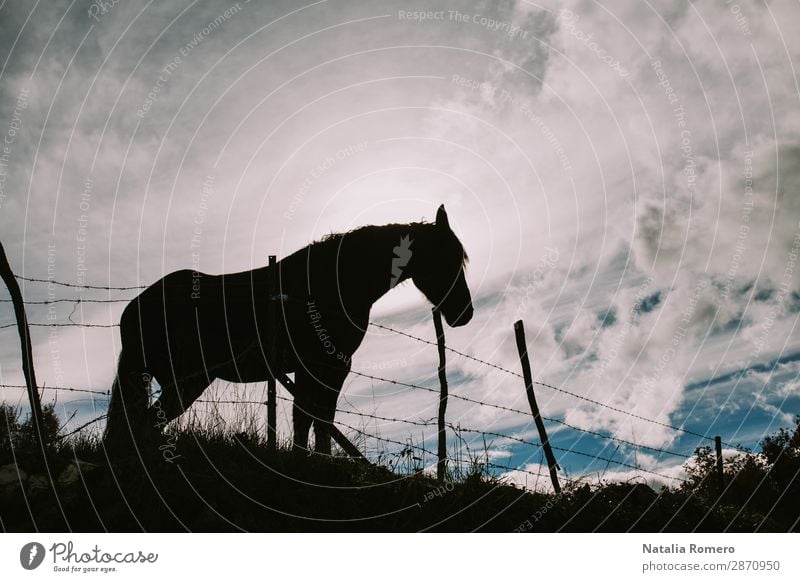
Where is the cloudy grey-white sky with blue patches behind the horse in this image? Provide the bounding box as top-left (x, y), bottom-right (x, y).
top-left (0, 0), bottom-right (800, 488)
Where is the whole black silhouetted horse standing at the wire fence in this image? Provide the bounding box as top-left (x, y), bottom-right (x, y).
top-left (105, 206), bottom-right (472, 454)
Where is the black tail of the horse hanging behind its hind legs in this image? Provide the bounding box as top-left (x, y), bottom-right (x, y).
top-left (103, 349), bottom-right (153, 455)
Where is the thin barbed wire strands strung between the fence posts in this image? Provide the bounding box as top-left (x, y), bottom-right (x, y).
top-left (0, 275), bottom-right (734, 482)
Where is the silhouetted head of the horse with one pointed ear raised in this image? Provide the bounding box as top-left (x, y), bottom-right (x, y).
top-left (411, 204), bottom-right (472, 327)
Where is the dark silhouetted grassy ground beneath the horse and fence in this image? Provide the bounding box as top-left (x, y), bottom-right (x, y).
top-left (0, 405), bottom-right (800, 532)
